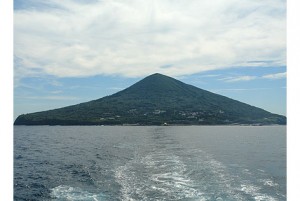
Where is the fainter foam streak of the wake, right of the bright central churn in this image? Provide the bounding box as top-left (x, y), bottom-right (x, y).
top-left (178, 150), bottom-right (278, 201)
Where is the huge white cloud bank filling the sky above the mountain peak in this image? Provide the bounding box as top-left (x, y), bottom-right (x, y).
top-left (14, 0), bottom-right (286, 79)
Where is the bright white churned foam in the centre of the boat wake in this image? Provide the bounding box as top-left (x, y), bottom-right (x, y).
top-left (115, 152), bottom-right (205, 201)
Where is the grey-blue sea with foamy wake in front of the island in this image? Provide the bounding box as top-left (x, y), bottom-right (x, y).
top-left (14, 126), bottom-right (286, 201)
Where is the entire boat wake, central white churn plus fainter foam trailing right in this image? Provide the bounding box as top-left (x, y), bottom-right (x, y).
top-left (115, 147), bottom-right (279, 201)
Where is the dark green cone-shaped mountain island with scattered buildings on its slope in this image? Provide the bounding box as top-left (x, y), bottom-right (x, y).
top-left (15, 73), bottom-right (286, 125)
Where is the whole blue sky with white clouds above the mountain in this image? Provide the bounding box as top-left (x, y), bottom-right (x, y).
top-left (13, 0), bottom-right (287, 119)
